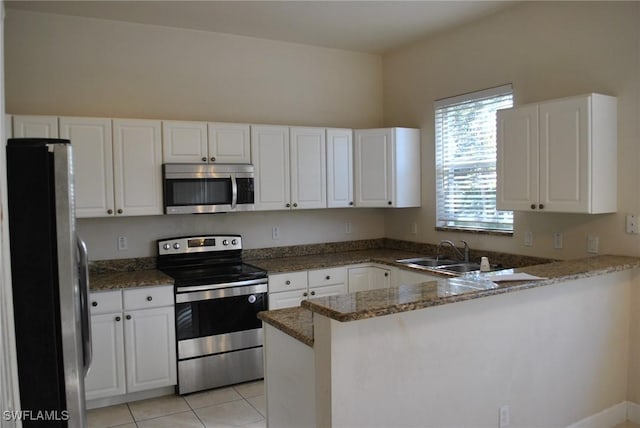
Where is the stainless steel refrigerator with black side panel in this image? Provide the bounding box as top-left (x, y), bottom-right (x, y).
top-left (7, 138), bottom-right (91, 427)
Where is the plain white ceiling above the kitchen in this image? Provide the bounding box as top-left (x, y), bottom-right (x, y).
top-left (5, 0), bottom-right (513, 53)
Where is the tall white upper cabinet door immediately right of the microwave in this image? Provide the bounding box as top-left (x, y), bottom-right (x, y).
top-left (251, 125), bottom-right (291, 210)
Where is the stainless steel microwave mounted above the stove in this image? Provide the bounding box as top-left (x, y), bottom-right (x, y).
top-left (162, 163), bottom-right (254, 214)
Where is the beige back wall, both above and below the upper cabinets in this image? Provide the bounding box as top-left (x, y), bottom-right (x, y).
top-left (5, 9), bottom-right (384, 260)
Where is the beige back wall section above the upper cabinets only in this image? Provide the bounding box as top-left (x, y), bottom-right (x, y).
top-left (6, 9), bottom-right (382, 127)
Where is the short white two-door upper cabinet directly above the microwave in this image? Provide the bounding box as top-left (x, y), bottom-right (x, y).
top-left (162, 120), bottom-right (251, 164)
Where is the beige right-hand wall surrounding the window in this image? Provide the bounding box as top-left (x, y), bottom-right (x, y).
top-left (383, 2), bottom-right (640, 258)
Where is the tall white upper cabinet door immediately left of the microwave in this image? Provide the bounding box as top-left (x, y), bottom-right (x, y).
top-left (113, 119), bottom-right (162, 215)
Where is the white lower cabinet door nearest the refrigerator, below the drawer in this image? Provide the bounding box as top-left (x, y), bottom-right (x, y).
top-left (84, 312), bottom-right (126, 400)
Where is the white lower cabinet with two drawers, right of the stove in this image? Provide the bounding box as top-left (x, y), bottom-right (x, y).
top-left (269, 267), bottom-right (347, 309)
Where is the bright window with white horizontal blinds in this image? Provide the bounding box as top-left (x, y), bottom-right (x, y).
top-left (435, 85), bottom-right (513, 232)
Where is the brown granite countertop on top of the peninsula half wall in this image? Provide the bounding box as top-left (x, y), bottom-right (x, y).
top-left (259, 255), bottom-right (640, 346)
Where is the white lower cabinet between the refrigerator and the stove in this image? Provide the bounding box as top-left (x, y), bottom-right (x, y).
top-left (85, 285), bottom-right (177, 400)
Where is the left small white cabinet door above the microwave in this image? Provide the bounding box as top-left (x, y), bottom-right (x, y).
top-left (162, 120), bottom-right (209, 163)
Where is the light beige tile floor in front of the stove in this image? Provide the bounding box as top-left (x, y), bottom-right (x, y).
top-left (87, 381), bottom-right (267, 428)
